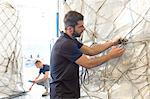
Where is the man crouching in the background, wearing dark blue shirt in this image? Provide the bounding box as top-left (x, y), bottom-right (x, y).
top-left (32, 60), bottom-right (49, 96)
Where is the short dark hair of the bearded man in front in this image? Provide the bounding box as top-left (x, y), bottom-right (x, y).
top-left (64, 11), bottom-right (84, 29)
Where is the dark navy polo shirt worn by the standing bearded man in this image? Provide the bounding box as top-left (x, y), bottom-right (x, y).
top-left (50, 33), bottom-right (83, 99)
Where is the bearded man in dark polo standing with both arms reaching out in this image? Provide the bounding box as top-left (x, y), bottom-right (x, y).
top-left (50, 11), bottom-right (124, 99)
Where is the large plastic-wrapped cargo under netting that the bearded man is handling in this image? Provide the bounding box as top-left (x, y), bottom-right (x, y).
top-left (58, 0), bottom-right (150, 99)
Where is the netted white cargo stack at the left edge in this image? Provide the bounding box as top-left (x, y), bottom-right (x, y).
top-left (0, 3), bottom-right (23, 98)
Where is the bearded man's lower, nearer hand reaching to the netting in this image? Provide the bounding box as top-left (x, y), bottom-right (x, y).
top-left (108, 46), bottom-right (125, 58)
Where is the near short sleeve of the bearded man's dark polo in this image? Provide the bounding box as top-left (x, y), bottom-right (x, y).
top-left (60, 41), bottom-right (82, 62)
